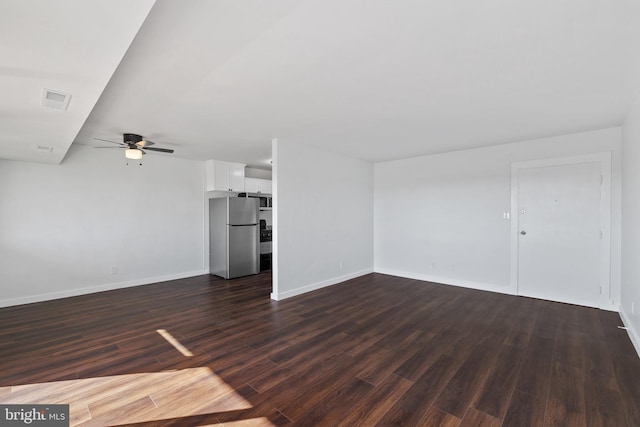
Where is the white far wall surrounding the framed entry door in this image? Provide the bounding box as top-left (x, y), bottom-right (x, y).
top-left (374, 128), bottom-right (621, 304)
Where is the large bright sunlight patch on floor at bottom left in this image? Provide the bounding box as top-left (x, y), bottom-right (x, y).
top-left (0, 367), bottom-right (254, 426)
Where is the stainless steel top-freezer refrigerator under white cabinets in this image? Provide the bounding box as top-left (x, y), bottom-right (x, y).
top-left (209, 197), bottom-right (260, 279)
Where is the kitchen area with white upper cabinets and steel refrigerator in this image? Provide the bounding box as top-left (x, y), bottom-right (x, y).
top-left (205, 160), bottom-right (273, 279)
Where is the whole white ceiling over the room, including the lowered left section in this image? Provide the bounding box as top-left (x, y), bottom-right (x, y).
top-left (0, 0), bottom-right (640, 168)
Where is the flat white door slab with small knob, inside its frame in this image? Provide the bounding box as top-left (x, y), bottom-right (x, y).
top-left (517, 161), bottom-right (603, 307)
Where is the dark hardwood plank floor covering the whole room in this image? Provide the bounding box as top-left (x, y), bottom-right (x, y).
top-left (0, 274), bottom-right (640, 427)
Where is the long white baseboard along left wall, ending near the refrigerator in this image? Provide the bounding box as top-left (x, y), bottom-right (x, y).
top-left (0, 270), bottom-right (209, 307)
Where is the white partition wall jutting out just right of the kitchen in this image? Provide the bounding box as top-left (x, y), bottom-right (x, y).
top-left (272, 141), bottom-right (373, 300)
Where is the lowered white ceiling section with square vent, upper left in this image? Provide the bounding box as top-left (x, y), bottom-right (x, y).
top-left (0, 0), bottom-right (153, 163)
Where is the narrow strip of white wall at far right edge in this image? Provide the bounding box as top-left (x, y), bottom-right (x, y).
top-left (620, 91), bottom-right (640, 354)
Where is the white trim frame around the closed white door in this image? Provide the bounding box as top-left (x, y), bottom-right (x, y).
top-left (510, 151), bottom-right (612, 309)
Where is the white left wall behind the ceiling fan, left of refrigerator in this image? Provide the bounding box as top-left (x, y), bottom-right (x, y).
top-left (0, 146), bottom-right (207, 306)
